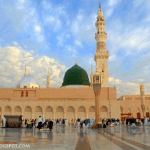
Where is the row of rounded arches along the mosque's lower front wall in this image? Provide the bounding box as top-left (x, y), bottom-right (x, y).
top-left (0, 106), bottom-right (108, 120)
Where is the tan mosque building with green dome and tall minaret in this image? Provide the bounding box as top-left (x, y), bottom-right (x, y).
top-left (0, 7), bottom-right (150, 120)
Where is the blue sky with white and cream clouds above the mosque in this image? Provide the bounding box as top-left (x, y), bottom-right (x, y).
top-left (0, 0), bottom-right (150, 97)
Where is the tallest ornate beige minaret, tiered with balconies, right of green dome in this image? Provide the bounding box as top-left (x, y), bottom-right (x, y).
top-left (94, 6), bottom-right (109, 87)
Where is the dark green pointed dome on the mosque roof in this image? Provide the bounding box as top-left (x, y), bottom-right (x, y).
top-left (62, 64), bottom-right (90, 86)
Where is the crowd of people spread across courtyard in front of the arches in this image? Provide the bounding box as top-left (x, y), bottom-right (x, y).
top-left (1, 116), bottom-right (150, 131)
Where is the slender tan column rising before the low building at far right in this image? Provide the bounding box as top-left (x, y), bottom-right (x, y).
top-left (140, 83), bottom-right (145, 117)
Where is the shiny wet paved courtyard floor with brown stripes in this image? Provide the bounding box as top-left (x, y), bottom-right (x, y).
top-left (0, 125), bottom-right (150, 150)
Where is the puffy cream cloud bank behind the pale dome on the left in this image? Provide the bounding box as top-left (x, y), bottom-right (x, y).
top-left (0, 45), bottom-right (66, 87)
